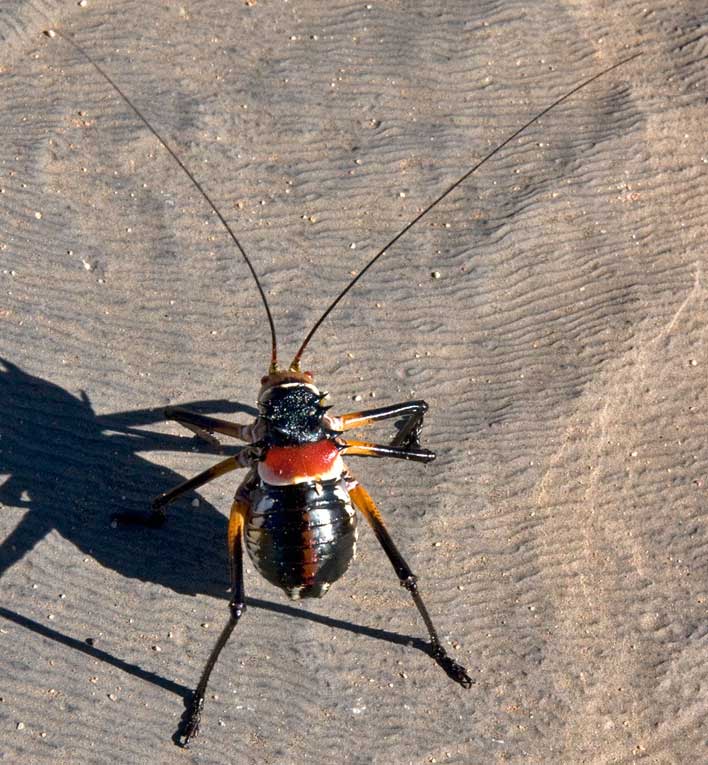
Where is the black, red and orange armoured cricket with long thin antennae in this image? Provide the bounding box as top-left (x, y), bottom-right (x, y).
top-left (50, 32), bottom-right (641, 746)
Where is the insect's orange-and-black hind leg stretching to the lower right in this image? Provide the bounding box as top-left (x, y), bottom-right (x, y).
top-left (349, 484), bottom-right (472, 688)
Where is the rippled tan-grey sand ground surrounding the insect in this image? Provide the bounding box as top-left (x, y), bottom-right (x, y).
top-left (0, 0), bottom-right (708, 765)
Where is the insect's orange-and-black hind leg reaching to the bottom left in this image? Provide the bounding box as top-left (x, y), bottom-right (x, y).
top-left (177, 490), bottom-right (249, 748)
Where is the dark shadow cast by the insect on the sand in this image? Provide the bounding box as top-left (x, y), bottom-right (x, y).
top-left (0, 357), bottom-right (428, 697)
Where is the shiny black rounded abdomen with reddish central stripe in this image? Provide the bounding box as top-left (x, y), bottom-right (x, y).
top-left (246, 478), bottom-right (356, 599)
